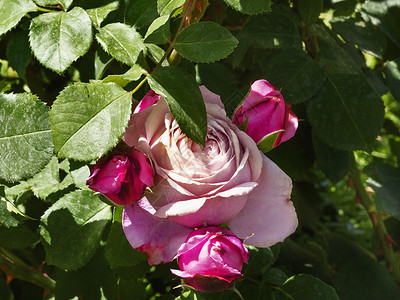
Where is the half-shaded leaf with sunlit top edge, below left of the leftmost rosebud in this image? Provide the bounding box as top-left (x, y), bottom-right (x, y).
top-left (40, 191), bottom-right (111, 270)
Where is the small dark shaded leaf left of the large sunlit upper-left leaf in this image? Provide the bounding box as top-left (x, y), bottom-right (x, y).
top-left (6, 31), bottom-right (32, 81)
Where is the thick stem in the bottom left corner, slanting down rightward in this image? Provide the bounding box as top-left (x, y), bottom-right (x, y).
top-left (0, 247), bottom-right (56, 294)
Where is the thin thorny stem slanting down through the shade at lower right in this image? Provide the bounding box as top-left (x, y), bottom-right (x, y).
top-left (350, 153), bottom-right (400, 282)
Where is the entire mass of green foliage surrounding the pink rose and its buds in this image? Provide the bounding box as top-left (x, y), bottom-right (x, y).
top-left (0, 0), bottom-right (400, 300)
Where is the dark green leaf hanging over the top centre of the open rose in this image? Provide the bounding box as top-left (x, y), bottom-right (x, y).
top-left (148, 67), bottom-right (207, 145)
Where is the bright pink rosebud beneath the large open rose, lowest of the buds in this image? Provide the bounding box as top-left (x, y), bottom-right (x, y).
top-left (171, 227), bottom-right (249, 292)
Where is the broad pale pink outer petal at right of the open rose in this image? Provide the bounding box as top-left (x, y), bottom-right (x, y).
top-left (228, 155), bottom-right (298, 247)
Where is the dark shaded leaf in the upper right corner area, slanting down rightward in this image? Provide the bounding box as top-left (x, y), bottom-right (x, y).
top-left (331, 18), bottom-right (386, 58)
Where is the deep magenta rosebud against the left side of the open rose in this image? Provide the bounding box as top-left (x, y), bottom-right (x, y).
top-left (86, 147), bottom-right (154, 205)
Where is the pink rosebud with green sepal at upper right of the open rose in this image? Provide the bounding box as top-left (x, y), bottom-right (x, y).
top-left (233, 79), bottom-right (298, 152)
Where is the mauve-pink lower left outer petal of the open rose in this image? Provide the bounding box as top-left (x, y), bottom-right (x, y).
top-left (122, 197), bottom-right (193, 265)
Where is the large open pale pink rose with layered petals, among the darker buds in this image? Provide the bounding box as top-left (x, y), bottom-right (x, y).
top-left (123, 87), bottom-right (297, 264)
